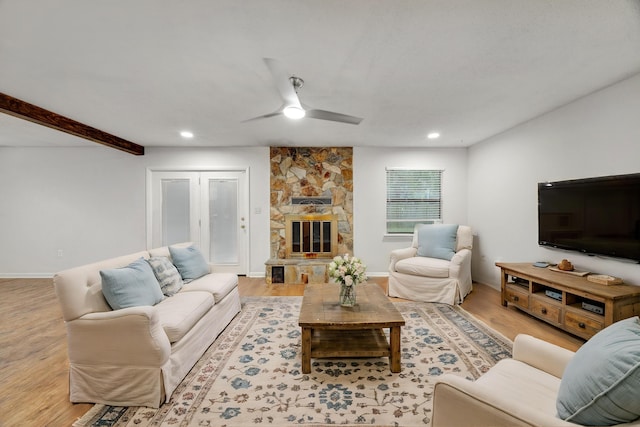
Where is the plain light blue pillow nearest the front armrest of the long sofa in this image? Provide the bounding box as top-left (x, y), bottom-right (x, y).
top-left (100, 258), bottom-right (164, 310)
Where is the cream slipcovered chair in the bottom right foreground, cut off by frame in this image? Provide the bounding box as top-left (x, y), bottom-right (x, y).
top-left (431, 334), bottom-right (640, 427)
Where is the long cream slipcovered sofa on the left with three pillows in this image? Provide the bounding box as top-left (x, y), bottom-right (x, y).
top-left (53, 244), bottom-right (240, 408)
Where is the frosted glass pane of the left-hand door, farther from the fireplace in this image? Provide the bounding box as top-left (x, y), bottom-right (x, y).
top-left (162, 179), bottom-right (191, 246)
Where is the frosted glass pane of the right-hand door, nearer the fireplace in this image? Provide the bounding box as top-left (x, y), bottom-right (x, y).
top-left (209, 180), bottom-right (238, 264)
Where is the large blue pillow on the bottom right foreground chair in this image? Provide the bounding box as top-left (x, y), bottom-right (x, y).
top-left (556, 316), bottom-right (640, 426)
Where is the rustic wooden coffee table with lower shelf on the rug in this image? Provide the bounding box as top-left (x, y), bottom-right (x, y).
top-left (298, 283), bottom-right (405, 374)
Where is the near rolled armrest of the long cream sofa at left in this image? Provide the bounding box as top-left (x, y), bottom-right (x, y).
top-left (66, 306), bottom-right (171, 367)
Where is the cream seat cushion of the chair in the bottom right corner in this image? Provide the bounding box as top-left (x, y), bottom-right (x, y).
top-left (476, 359), bottom-right (565, 425)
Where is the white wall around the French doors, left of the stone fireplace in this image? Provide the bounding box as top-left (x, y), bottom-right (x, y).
top-left (0, 144), bottom-right (269, 277)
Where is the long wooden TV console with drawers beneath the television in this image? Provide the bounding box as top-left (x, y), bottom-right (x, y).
top-left (496, 262), bottom-right (640, 339)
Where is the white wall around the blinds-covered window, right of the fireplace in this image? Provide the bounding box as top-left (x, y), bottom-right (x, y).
top-left (353, 147), bottom-right (467, 276)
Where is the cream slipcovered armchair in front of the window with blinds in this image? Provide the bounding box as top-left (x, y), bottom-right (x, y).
top-left (387, 224), bottom-right (473, 305)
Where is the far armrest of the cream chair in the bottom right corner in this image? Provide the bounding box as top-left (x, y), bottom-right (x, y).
top-left (513, 334), bottom-right (575, 378)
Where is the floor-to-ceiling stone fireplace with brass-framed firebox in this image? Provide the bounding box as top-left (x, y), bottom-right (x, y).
top-left (265, 147), bottom-right (353, 283)
